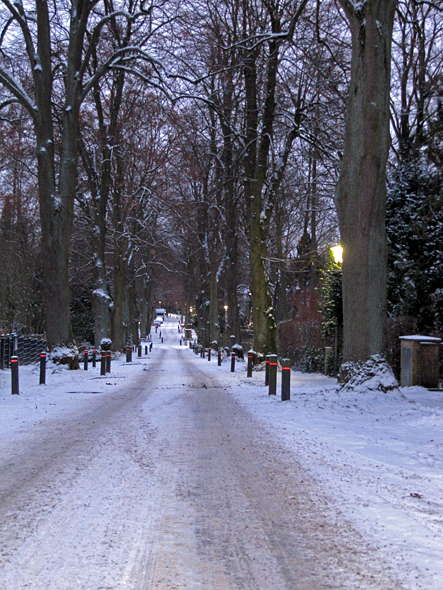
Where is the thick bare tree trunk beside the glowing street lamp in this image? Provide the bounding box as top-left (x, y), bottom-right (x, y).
top-left (335, 0), bottom-right (397, 361)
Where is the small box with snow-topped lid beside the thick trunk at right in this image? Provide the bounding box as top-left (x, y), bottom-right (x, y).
top-left (400, 336), bottom-right (441, 388)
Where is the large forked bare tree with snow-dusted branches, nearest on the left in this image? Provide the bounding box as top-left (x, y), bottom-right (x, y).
top-left (0, 0), bottom-right (163, 346)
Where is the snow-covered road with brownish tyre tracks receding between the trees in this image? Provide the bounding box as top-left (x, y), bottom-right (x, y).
top-left (0, 321), bottom-right (438, 590)
